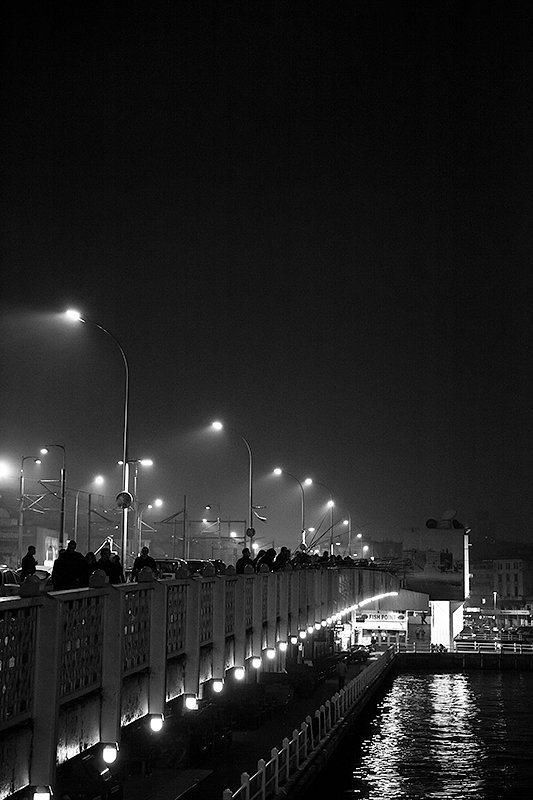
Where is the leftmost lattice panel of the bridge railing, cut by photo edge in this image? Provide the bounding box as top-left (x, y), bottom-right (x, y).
top-left (0, 608), bottom-right (37, 722)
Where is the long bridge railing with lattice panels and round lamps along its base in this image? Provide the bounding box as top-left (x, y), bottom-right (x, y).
top-left (0, 569), bottom-right (398, 800)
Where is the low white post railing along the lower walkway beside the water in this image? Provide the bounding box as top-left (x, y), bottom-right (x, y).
top-left (222, 647), bottom-right (395, 800)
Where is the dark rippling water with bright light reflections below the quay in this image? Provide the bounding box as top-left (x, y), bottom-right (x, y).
top-left (316, 671), bottom-right (533, 800)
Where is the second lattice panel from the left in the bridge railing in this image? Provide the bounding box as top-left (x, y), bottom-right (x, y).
top-left (59, 595), bottom-right (105, 699)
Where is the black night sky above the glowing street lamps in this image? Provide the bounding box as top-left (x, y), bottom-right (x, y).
top-left (0, 0), bottom-right (533, 546)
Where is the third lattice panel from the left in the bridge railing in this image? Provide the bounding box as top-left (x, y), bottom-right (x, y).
top-left (122, 589), bottom-right (151, 672)
